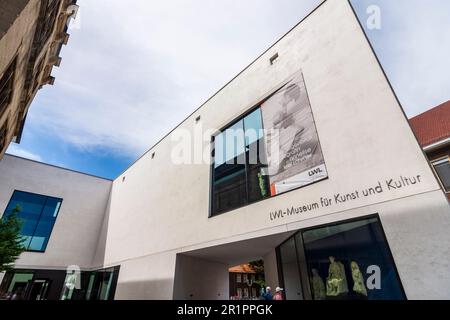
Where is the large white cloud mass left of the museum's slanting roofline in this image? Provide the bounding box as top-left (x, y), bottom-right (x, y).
top-left (27, 0), bottom-right (321, 156)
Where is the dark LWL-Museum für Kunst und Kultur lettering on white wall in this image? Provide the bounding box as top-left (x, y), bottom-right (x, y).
top-left (269, 175), bottom-right (422, 221)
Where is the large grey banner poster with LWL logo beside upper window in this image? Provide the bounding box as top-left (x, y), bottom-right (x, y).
top-left (261, 71), bottom-right (328, 196)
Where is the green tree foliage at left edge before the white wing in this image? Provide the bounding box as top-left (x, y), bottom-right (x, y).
top-left (0, 206), bottom-right (25, 272)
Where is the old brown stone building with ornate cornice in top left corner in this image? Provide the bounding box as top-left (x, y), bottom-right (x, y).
top-left (0, 0), bottom-right (77, 159)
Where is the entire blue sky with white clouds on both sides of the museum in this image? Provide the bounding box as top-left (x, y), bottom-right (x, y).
top-left (8, 0), bottom-right (450, 178)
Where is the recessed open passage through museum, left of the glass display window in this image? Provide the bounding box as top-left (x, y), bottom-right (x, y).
top-left (173, 232), bottom-right (294, 300)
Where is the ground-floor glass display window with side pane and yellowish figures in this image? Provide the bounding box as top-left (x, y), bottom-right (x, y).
top-left (278, 217), bottom-right (405, 300)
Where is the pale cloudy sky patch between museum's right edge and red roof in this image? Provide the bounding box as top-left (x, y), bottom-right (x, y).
top-left (353, 0), bottom-right (450, 117)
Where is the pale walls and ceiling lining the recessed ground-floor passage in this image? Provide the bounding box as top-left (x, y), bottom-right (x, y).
top-left (173, 232), bottom-right (294, 300)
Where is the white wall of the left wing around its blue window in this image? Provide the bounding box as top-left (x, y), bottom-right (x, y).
top-left (0, 155), bottom-right (112, 270)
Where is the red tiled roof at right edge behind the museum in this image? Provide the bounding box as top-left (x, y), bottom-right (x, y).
top-left (409, 101), bottom-right (450, 147)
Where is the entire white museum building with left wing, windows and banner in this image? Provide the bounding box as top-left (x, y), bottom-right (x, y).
top-left (0, 0), bottom-right (450, 300)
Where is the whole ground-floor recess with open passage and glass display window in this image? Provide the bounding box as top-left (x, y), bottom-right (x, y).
top-left (173, 215), bottom-right (406, 300)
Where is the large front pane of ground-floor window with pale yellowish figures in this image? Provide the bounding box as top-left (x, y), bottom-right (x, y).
top-left (303, 218), bottom-right (404, 300)
